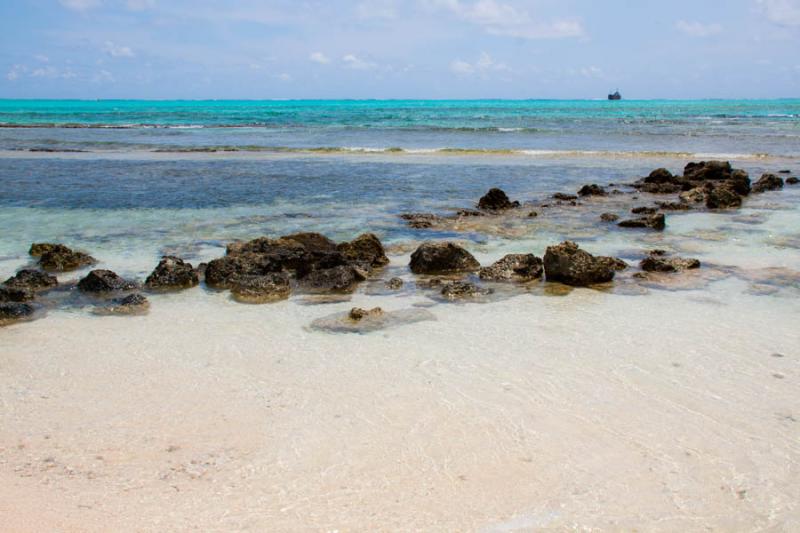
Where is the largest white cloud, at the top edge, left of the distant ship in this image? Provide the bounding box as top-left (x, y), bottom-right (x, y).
top-left (427, 0), bottom-right (584, 39)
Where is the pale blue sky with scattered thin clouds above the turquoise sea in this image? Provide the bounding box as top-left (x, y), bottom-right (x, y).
top-left (0, 0), bottom-right (800, 99)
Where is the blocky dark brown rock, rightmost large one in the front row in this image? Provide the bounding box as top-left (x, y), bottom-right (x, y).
top-left (544, 241), bottom-right (614, 286)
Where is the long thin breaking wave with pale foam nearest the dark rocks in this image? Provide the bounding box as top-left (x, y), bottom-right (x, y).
top-left (6, 145), bottom-right (780, 160)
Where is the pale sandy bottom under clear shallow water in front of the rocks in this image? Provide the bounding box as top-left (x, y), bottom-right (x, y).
top-left (0, 281), bottom-right (800, 532)
